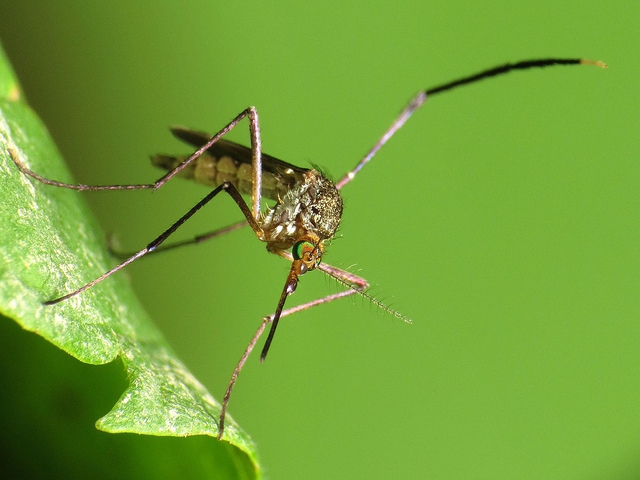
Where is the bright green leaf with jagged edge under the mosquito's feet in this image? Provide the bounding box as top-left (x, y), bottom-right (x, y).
top-left (0, 41), bottom-right (260, 478)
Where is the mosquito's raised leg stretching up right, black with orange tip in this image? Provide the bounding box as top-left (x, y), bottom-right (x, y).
top-left (336, 58), bottom-right (607, 190)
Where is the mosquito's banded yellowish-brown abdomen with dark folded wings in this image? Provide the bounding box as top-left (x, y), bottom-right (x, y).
top-left (151, 127), bottom-right (309, 200)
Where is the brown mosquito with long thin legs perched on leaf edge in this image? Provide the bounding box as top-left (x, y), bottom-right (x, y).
top-left (9, 58), bottom-right (606, 439)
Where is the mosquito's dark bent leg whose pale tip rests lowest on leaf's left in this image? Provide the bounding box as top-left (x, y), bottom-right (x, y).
top-left (44, 182), bottom-right (263, 305)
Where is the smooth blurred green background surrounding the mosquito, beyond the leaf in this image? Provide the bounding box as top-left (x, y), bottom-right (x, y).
top-left (0, 1), bottom-right (640, 479)
